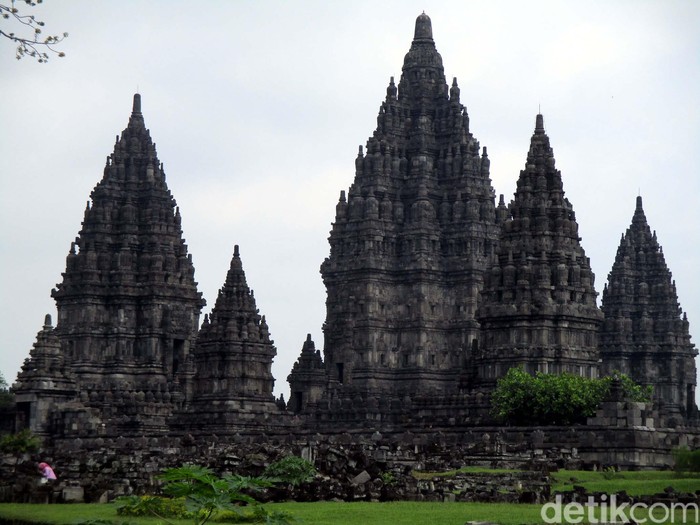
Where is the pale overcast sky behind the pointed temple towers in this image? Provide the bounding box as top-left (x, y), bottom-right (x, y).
top-left (0, 0), bottom-right (700, 397)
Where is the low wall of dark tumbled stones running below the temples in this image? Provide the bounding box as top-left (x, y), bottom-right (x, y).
top-left (0, 426), bottom-right (700, 501)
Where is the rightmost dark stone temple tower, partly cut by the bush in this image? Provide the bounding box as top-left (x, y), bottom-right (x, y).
top-left (600, 197), bottom-right (697, 425)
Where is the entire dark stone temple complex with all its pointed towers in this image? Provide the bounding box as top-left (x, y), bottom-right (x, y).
top-left (6, 14), bottom-right (698, 464)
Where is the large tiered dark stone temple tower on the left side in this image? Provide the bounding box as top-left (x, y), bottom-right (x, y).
top-left (17, 94), bottom-right (205, 433)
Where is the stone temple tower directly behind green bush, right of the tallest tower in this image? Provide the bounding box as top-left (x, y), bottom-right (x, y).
top-left (474, 115), bottom-right (603, 387)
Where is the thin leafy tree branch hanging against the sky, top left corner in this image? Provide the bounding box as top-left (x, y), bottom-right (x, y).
top-left (0, 0), bottom-right (68, 63)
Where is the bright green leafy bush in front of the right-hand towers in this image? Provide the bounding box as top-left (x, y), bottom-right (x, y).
top-left (491, 368), bottom-right (651, 426)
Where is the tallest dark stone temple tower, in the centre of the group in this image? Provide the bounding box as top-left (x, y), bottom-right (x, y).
top-left (321, 14), bottom-right (498, 398)
